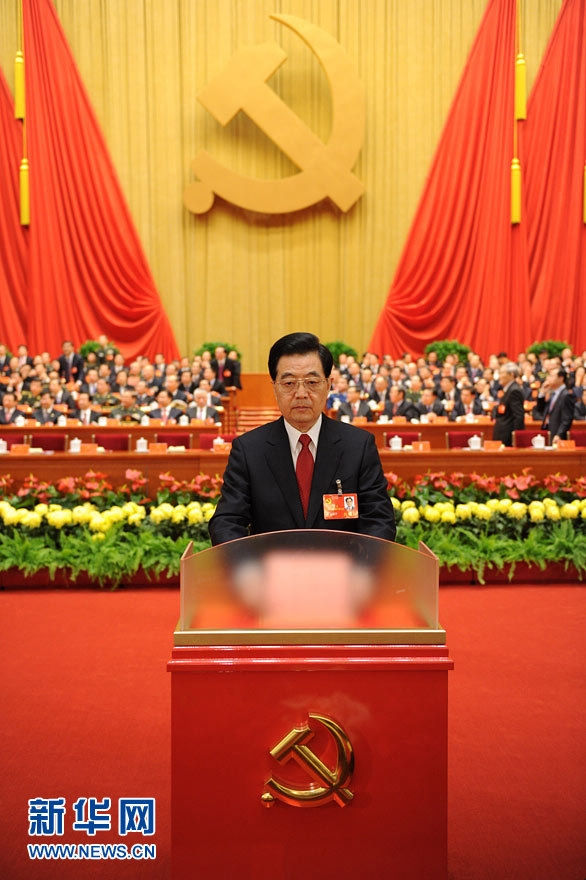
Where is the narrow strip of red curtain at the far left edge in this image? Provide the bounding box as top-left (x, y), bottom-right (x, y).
top-left (0, 70), bottom-right (28, 352)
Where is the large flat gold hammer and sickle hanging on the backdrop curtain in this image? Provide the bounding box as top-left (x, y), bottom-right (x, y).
top-left (183, 15), bottom-right (365, 214)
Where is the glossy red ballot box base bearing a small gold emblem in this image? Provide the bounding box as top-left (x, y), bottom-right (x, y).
top-left (169, 645), bottom-right (452, 880)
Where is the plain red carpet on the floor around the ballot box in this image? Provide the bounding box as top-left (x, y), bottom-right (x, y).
top-left (0, 586), bottom-right (586, 880)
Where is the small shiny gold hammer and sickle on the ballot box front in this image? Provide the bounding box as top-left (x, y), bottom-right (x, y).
top-left (262, 712), bottom-right (354, 807)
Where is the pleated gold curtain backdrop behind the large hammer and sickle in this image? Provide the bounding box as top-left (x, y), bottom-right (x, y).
top-left (0, 0), bottom-right (562, 372)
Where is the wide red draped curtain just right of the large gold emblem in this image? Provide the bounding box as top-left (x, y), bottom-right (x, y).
top-left (370, 0), bottom-right (531, 357)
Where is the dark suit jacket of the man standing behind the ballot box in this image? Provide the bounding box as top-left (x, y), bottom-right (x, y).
top-left (209, 416), bottom-right (395, 544)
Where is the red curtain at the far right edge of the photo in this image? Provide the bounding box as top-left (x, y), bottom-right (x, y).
top-left (525, 0), bottom-right (586, 352)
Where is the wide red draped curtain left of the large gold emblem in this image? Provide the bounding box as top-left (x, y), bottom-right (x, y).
top-left (23, 0), bottom-right (178, 359)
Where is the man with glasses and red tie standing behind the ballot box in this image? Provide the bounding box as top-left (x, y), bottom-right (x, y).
top-left (209, 333), bottom-right (395, 544)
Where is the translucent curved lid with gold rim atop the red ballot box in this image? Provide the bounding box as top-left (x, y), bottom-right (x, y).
top-left (175, 529), bottom-right (445, 645)
